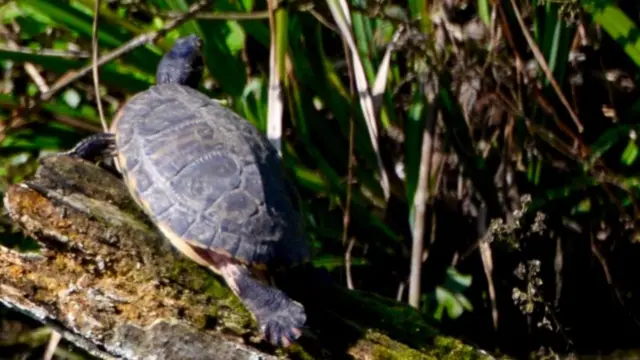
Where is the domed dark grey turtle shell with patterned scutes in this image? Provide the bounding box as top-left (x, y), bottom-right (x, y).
top-left (112, 84), bottom-right (309, 267)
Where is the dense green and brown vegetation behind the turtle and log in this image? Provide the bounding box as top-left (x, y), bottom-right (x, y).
top-left (0, 0), bottom-right (640, 357)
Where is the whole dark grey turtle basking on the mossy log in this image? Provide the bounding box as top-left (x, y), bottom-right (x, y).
top-left (66, 35), bottom-right (310, 347)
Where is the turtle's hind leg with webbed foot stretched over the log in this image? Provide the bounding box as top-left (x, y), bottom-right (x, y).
top-left (221, 263), bottom-right (307, 347)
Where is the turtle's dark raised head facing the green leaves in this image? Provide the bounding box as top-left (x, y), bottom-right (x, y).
top-left (156, 35), bottom-right (204, 88)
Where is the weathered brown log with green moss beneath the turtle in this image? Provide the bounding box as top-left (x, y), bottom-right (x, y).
top-left (0, 156), bottom-right (498, 360)
